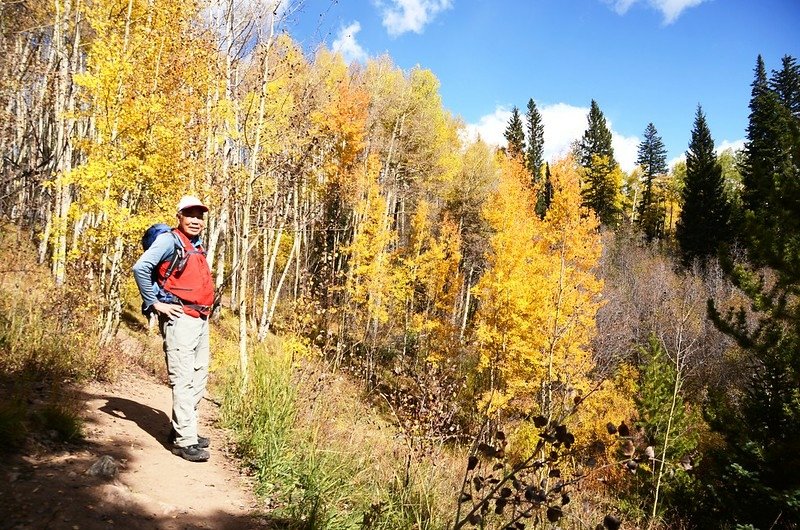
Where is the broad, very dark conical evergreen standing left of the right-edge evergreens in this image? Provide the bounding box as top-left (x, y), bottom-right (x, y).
top-left (676, 105), bottom-right (731, 266)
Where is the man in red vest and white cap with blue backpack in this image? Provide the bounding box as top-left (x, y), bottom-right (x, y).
top-left (133, 195), bottom-right (214, 462)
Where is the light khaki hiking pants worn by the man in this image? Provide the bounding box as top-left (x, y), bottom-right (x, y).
top-left (159, 314), bottom-right (209, 447)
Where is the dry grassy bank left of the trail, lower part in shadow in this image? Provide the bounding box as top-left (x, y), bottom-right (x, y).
top-left (0, 224), bottom-right (114, 451)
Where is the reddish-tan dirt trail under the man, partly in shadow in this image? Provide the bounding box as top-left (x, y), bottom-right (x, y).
top-left (0, 375), bottom-right (272, 530)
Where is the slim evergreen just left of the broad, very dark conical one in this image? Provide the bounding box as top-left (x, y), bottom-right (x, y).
top-left (636, 123), bottom-right (667, 241)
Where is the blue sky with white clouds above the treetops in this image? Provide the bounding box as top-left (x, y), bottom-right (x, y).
top-left (288, 0), bottom-right (800, 170)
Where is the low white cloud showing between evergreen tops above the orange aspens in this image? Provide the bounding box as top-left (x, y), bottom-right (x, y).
top-left (465, 103), bottom-right (640, 171)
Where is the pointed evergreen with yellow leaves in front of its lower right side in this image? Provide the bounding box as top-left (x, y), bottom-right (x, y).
top-left (577, 100), bottom-right (620, 226)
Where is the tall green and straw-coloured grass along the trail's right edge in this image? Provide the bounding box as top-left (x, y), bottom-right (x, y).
top-left (217, 334), bottom-right (460, 530)
